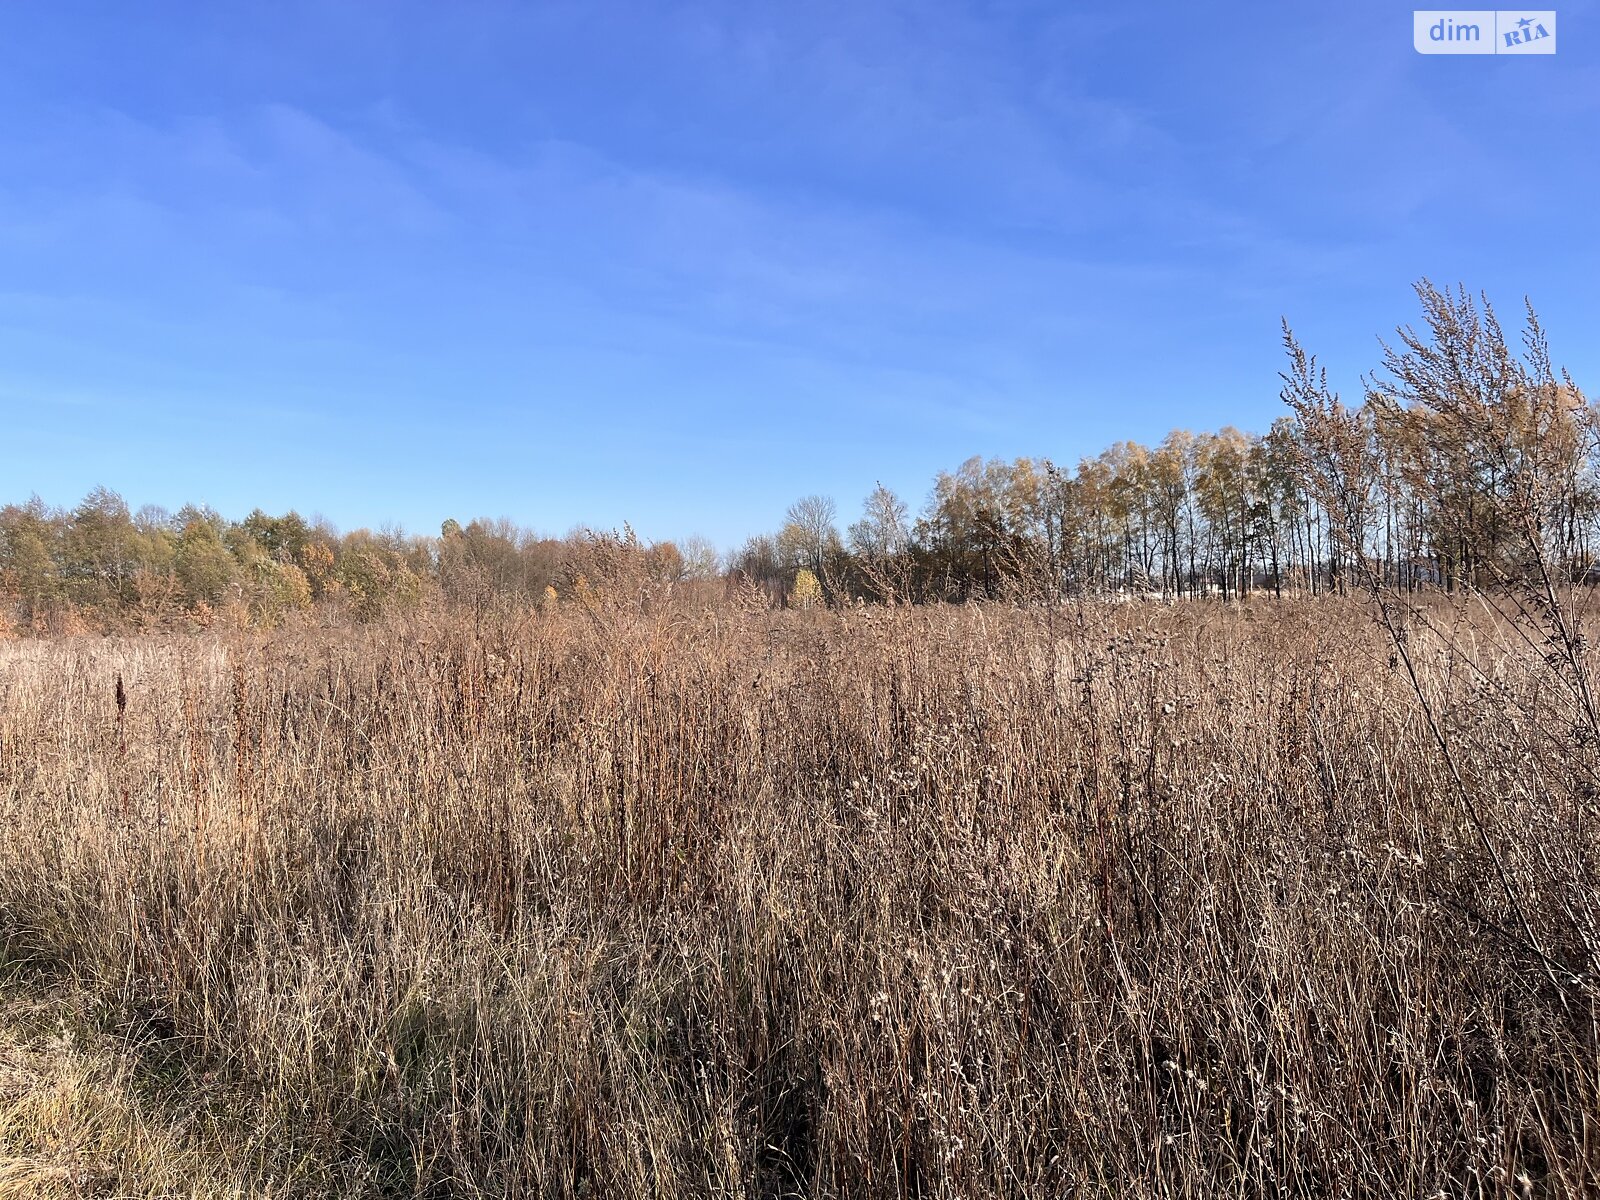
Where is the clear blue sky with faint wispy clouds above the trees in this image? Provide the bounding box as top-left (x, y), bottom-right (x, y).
top-left (0, 0), bottom-right (1600, 546)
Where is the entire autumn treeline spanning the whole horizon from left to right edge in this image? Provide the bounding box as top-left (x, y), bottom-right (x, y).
top-left (0, 282), bottom-right (1600, 629)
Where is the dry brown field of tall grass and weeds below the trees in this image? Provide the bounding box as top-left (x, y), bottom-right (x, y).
top-left (0, 600), bottom-right (1600, 1198)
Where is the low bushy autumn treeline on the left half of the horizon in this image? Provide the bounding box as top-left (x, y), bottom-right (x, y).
top-left (0, 488), bottom-right (717, 632)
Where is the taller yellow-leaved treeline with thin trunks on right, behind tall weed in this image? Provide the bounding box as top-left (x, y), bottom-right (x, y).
top-left (734, 282), bottom-right (1600, 600)
